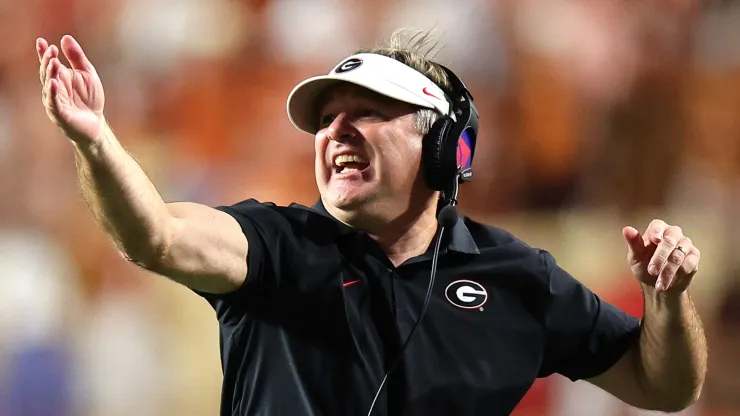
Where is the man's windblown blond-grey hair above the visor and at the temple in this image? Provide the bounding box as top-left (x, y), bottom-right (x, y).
top-left (356, 28), bottom-right (451, 134)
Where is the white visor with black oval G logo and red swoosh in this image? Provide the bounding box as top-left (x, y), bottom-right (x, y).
top-left (287, 53), bottom-right (450, 134)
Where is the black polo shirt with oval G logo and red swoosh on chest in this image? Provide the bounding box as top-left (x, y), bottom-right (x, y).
top-left (201, 200), bottom-right (640, 416)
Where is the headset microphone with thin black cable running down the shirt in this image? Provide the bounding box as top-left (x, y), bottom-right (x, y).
top-left (367, 167), bottom-right (466, 416)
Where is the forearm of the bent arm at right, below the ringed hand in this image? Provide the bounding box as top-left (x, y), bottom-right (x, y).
top-left (638, 285), bottom-right (707, 410)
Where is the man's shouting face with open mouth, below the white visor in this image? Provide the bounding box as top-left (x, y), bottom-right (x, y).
top-left (315, 85), bottom-right (432, 221)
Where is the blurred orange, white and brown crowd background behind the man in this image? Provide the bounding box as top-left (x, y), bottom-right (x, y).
top-left (0, 0), bottom-right (740, 416)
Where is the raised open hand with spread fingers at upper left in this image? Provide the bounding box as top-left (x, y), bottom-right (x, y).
top-left (36, 35), bottom-right (106, 146)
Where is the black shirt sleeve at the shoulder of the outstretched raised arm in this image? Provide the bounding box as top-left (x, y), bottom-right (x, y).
top-left (195, 199), bottom-right (281, 320)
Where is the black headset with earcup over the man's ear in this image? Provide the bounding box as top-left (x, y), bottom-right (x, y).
top-left (422, 64), bottom-right (478, 200)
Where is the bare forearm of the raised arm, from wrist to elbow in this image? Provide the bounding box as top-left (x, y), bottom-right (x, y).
top-left (74, 120), bottom-right (170, 265)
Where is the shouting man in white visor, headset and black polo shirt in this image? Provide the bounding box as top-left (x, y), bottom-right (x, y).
top-left (37, 33), bottom-right (706, 415)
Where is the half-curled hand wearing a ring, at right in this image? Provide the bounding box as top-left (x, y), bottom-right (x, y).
top-left (622, 220), bottom-right (700, 293)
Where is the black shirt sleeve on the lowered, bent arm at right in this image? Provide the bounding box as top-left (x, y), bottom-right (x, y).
top-left (540, 251), bottom-right (640, 381)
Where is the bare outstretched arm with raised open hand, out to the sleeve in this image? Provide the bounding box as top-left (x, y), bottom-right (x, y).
top-left (36, 36), bottom-right (248, 293)
